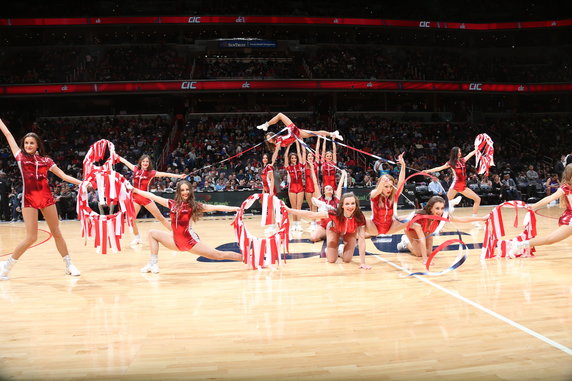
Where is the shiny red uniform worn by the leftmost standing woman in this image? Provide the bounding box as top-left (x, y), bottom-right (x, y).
top-left (16, 150), bottom-right (56, 209)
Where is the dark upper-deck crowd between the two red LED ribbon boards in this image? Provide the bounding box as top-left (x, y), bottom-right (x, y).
top-left (0, 44), bottom-right (572, 84)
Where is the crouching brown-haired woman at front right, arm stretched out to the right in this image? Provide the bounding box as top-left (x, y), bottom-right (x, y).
top-left (397, 196), bottom-right (489, 263)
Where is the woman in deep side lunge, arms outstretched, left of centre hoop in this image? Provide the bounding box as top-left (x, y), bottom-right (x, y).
top-left (133, 180), bottom-right (242, 274)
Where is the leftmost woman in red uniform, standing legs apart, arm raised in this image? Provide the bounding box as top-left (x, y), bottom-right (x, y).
top-left (0, 120), bottom-right (81, 280)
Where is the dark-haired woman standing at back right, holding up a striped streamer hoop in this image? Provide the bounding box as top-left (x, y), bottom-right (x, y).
top-left (425, 147), bottom-right (481, 217)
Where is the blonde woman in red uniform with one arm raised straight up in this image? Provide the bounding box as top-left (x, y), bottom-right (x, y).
top-left (366, 154), bottom-right (406, 236)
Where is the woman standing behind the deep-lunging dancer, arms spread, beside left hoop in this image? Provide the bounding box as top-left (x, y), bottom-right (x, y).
top-left (119, 155), bottom-right (186, 245)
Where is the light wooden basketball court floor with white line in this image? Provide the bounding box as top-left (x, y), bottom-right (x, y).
top-left (0, 207), bottom-right (572, 380)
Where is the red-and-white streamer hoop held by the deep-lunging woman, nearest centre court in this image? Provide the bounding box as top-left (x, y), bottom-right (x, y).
top-left (232, 193), bottom-right (290, 269)
